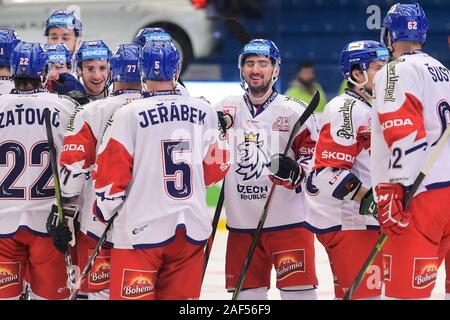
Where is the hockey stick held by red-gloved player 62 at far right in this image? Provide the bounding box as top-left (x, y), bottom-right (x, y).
top-left (344, 126), bottom-right (450, 300)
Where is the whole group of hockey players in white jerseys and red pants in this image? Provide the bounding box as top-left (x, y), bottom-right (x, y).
top-left (0, 4), bottom-right (450, 300)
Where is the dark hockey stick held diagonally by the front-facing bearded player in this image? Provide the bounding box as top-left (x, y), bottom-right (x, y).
top-left (232, 91), bottom-right (320, 300)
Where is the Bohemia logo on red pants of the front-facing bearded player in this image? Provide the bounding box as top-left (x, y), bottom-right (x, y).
top-left (273, 249), bottom-right (305, 280)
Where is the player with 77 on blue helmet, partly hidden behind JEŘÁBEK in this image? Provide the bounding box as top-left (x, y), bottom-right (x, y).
top-left (46, 44), bottom-right (142, 299)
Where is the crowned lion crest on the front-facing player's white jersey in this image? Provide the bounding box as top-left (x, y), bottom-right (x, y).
top-left (236, 132), bottom-right (269, 180)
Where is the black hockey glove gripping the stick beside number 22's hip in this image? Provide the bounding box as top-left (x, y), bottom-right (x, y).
top-left (46, 204), bottom-right (80, 253)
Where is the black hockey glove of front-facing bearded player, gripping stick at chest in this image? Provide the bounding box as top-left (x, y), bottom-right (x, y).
top-left (268, 153), bottom-right (305, 189)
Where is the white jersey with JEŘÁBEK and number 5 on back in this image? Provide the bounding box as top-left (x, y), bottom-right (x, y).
top-left (93, 91), bottom-right (229, 248)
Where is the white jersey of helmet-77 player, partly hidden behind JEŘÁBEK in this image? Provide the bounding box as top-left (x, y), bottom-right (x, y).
top-left (60, 90), bottom-right (142, 237)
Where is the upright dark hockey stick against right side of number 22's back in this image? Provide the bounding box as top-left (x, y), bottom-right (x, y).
top-left (44, 108), bottom-right (76, 292)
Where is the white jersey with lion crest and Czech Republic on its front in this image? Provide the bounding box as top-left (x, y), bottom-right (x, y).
top-left (215, 92), bottom-right (318, 231)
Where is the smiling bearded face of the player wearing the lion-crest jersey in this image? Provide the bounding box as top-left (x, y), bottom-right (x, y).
top-left (242, 55), bottom-right (274, 96)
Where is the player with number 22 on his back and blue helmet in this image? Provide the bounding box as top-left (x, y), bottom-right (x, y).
top-left (0, 42), bottom-right (76, 299)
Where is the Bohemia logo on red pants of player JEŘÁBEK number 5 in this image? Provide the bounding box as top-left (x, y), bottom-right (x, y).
top-left (122, 269), bottom-right (156, 299)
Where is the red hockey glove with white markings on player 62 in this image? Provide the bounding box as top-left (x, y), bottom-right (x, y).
top-left (375, 183), bottom-right (411, 236)
